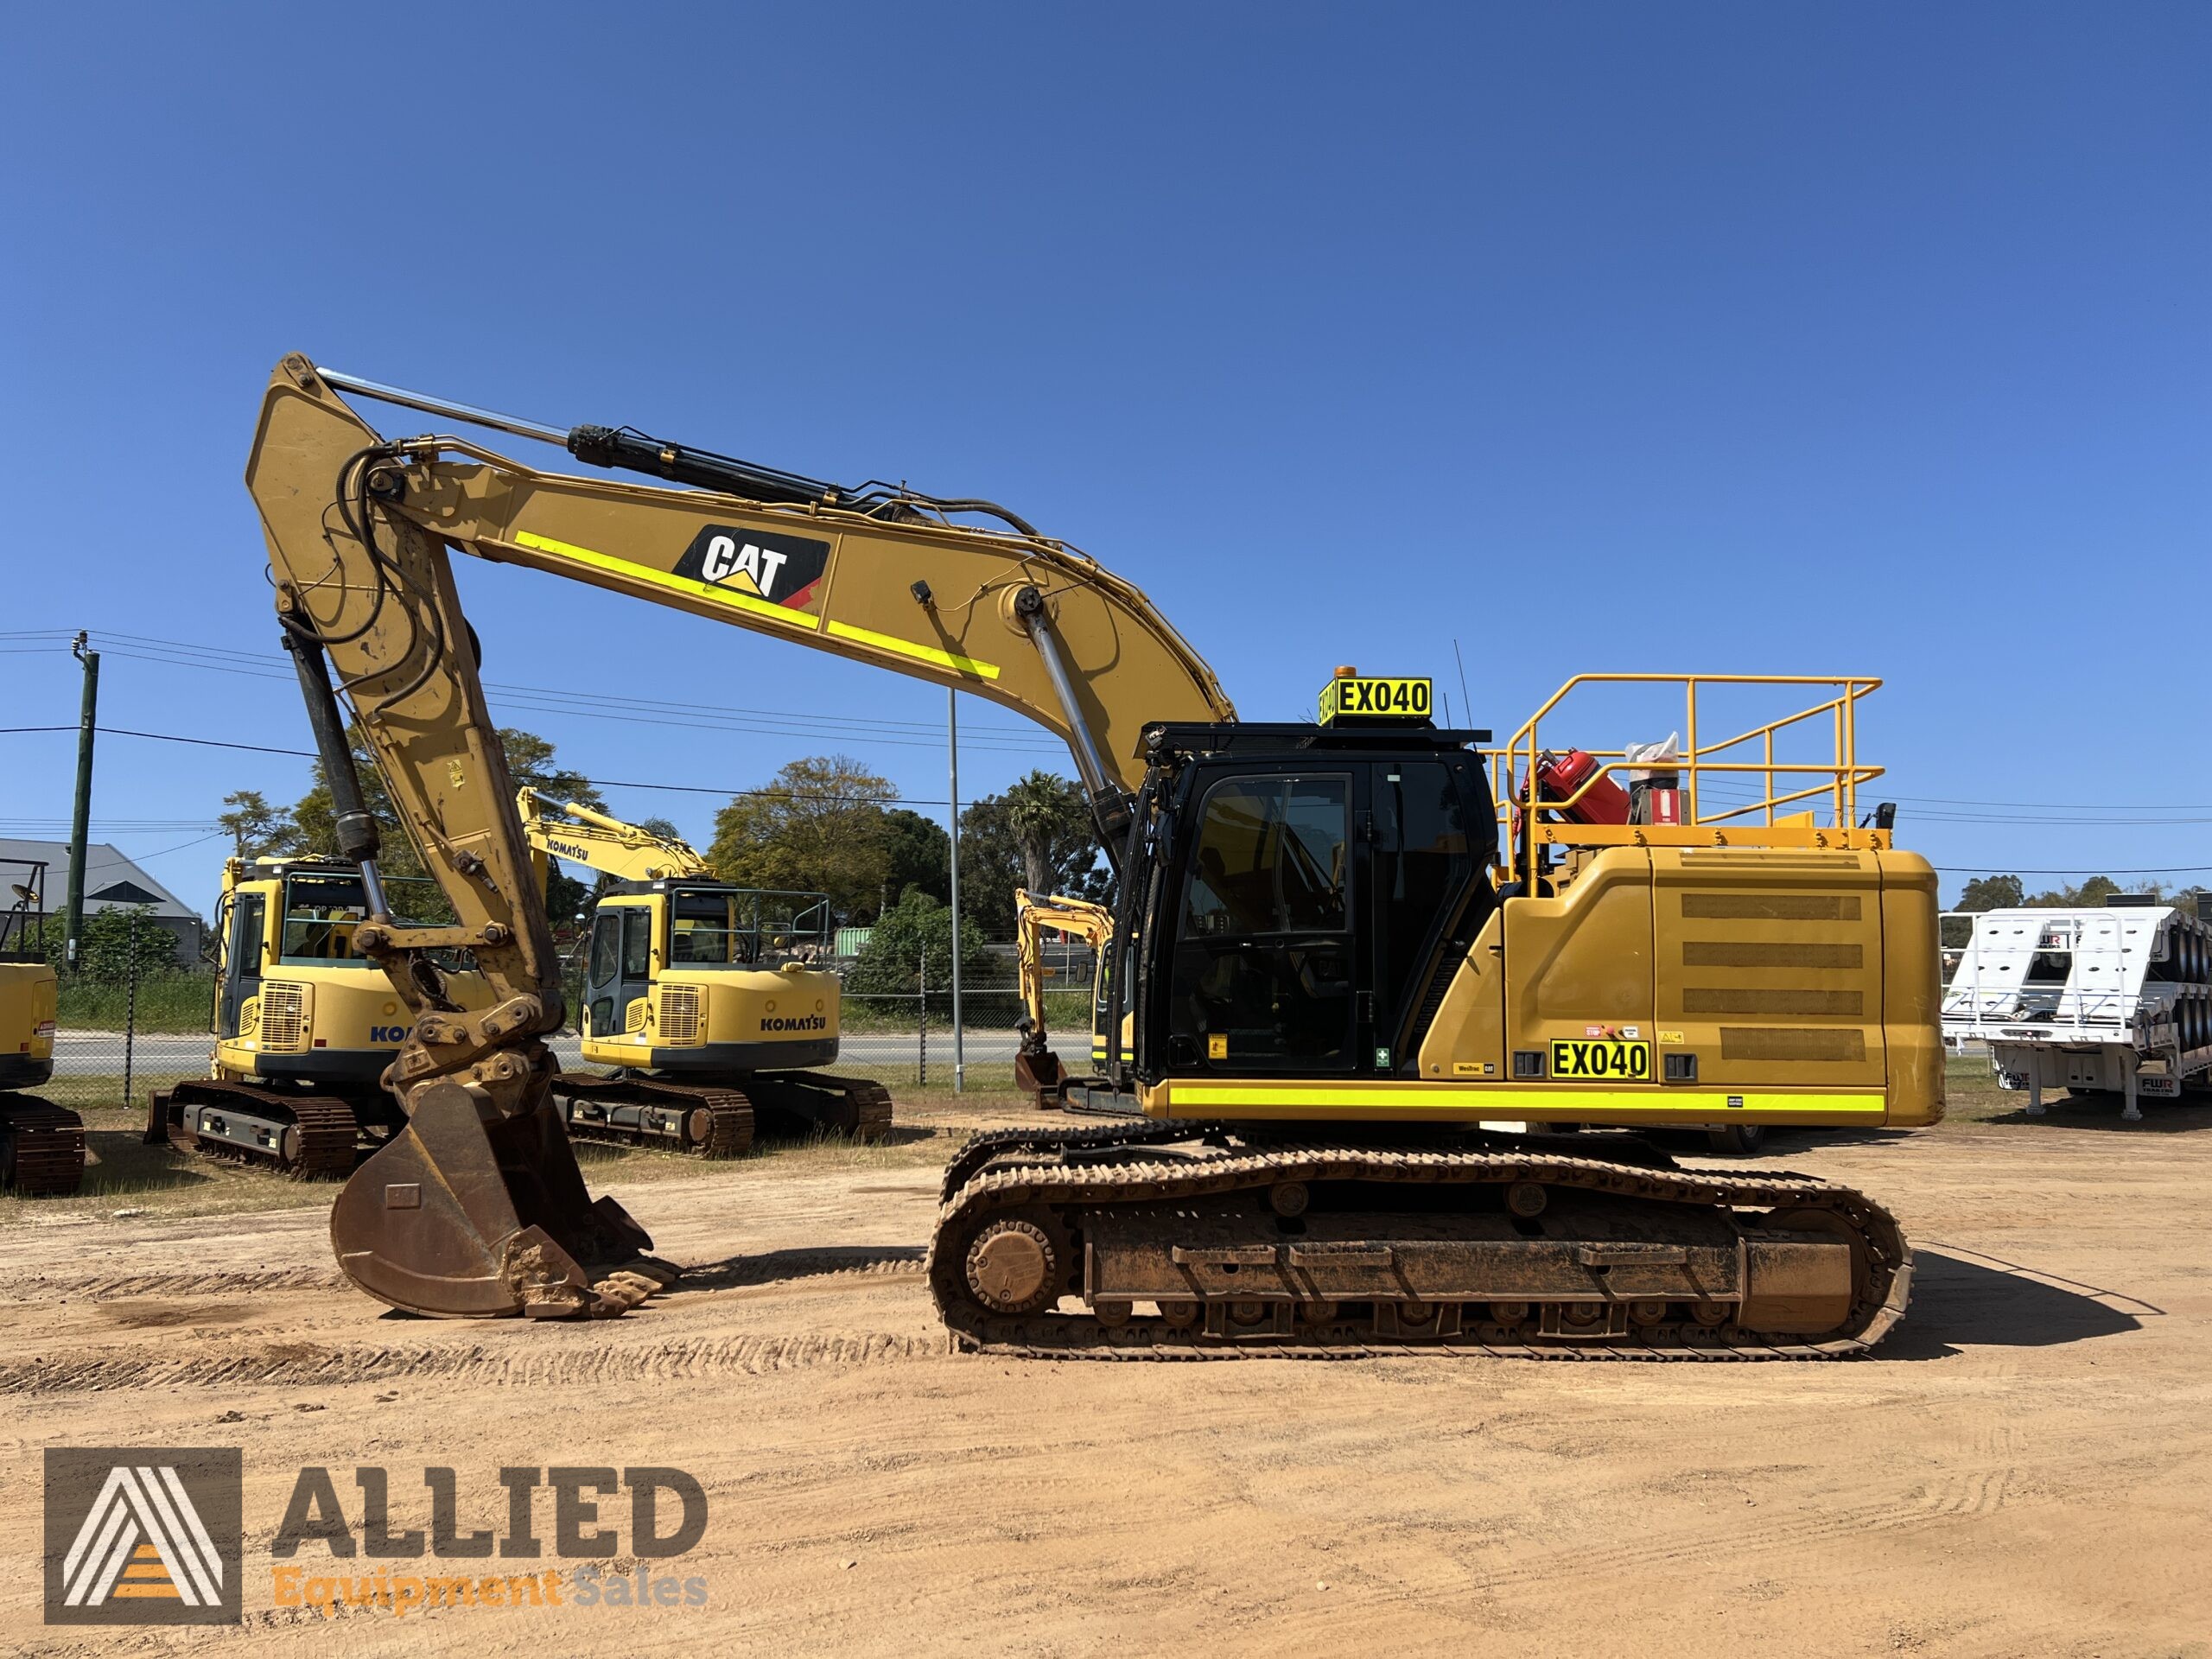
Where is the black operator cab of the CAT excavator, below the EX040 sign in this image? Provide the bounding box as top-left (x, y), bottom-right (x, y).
top-left (1137, 726), bottom-right (1496, 1079)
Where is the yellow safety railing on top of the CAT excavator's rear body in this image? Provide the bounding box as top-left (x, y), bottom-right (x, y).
top-left (1486, 675), bottom-right (1889, 885)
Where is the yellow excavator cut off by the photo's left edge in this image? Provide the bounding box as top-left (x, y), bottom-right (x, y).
top-left (0, 858), bottom-right (84, 1199)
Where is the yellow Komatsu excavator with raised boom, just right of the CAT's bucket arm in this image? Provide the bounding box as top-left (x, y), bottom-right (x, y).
top-left (515, 790), bottom-right (892, 1157)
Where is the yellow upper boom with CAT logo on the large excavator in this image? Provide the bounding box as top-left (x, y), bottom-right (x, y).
top-left (248, 356), bottom-right (1236, 856)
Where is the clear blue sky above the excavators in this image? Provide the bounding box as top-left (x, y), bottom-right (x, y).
top-left (0, 4), bottom-right (2212, 905)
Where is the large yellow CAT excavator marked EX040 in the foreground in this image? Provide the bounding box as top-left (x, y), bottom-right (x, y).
top-left (245, 356), bottom-right (1942, 1358)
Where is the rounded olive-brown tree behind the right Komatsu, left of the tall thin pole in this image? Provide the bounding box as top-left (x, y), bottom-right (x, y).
top-left (706, 754), bottom-right (898, 923)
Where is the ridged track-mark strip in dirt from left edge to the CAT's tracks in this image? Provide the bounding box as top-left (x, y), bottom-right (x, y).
top-left (0, 1332), bottom-right (951, 1395)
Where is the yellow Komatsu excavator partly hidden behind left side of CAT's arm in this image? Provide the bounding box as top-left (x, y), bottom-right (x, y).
top-left (146, 856), bottom-right (482, 1181)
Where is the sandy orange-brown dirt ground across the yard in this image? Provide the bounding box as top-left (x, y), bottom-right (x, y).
top-left (0, 1097), bottom-right (2212, 1656)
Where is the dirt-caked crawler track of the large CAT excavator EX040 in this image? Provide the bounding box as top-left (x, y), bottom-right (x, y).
top-left (927, 1123), bottom-right (1911, 1360)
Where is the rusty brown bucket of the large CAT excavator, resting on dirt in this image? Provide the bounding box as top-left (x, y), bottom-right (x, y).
top-left (329, 1084), bottom-right (677, 1319)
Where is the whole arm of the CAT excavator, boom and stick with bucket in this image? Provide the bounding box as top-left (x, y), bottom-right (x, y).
top-left (245, 354), bottom-right (1236, 1316)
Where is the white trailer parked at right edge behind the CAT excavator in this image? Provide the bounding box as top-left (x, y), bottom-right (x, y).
top-left (1942, 905), bottom-right (2212, 1123)
